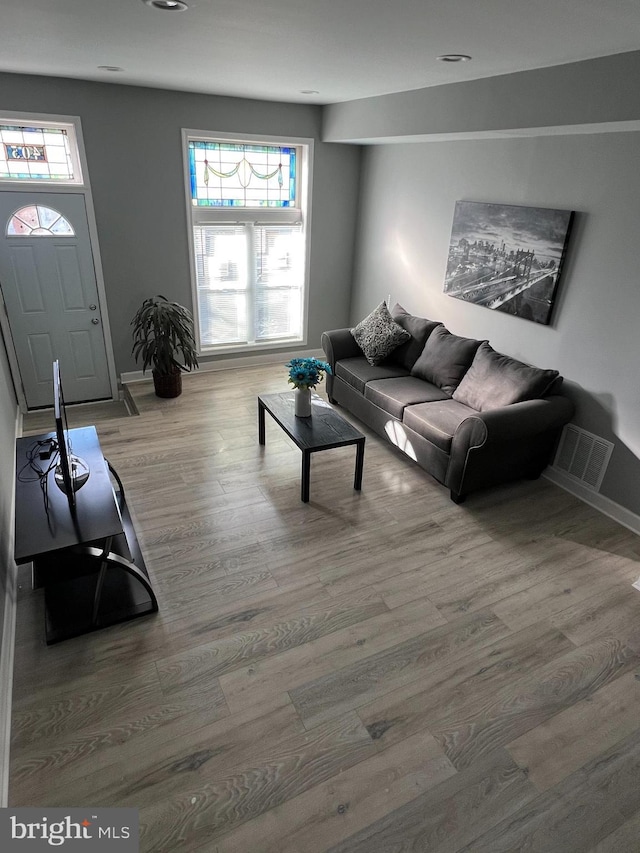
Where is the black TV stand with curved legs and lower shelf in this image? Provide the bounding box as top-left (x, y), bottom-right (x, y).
top-left (14, 427), bottom-right (158, 644)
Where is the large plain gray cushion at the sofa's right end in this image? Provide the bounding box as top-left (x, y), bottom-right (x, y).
top-left (453, 341), bottom-right (560, 412)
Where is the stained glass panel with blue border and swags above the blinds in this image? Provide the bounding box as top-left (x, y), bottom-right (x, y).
top-left (189, 140), bottom-right (297, 207)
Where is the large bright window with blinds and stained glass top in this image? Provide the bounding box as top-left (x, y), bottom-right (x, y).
top-left (185, 134), bottom-right (309, 351)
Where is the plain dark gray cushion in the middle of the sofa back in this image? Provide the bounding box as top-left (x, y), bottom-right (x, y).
top-left (411, 323), bottom-right (480, 396)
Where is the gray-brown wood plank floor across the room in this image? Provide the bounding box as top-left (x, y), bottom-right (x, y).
top-left (9, 366), bottom-right (640, 853)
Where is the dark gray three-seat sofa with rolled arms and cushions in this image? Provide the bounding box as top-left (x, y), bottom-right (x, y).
top-left (322, 303), bottom-right (573, 503)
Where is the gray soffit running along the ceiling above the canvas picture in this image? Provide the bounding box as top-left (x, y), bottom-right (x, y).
top-left (324, 51), bottom-right (640, 142)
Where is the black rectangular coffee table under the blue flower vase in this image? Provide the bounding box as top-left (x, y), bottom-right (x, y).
top-left (258, 391), bottom-right (365, 503)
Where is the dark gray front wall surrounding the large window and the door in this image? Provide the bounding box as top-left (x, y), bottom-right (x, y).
top-left (0, 74), bottom-right (359, 373)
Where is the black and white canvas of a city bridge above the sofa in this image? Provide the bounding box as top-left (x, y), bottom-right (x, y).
top-left (444, 201), bottom-right (573, 325)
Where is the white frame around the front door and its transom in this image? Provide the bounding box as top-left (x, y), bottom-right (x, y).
top-left (0, 110), bottom-right (119, 414)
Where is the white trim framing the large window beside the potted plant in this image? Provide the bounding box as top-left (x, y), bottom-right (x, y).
top-left (182, 128), bottom-right (314, 355)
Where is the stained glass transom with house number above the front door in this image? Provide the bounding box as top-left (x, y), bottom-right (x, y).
top-left (0, 124), bottom-right (76, 182)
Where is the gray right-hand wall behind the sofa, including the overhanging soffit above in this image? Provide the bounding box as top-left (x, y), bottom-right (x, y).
top-left (323, 51), bottom-right (640, 515)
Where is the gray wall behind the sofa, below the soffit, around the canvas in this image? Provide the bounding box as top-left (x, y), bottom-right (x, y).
top-left (351, 132), bottom-right (640, 514)
